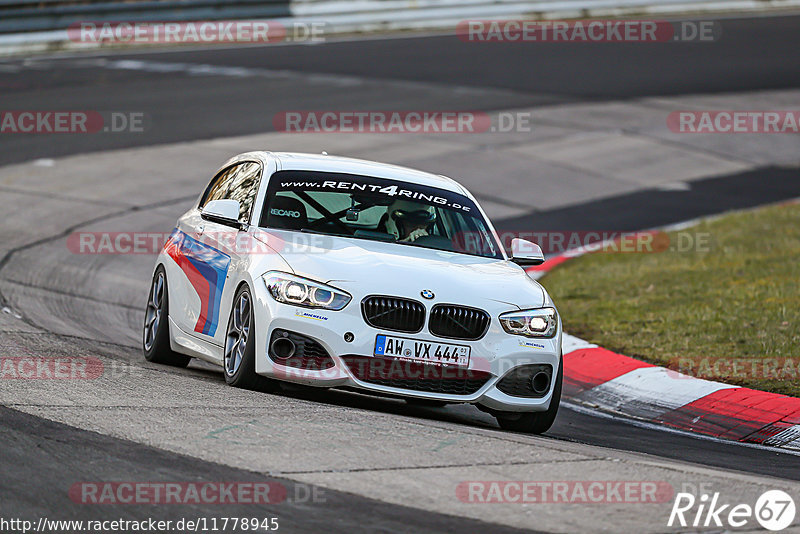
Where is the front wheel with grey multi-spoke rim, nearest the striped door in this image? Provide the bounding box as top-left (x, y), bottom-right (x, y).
top-left (223, 284), bottom-right (278, 392)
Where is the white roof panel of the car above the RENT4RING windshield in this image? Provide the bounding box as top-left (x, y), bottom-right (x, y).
top-left (264, 152), bottom-right (469, 195)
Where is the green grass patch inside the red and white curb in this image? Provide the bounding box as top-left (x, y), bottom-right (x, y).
top-left (542, 204), bottom-right (800, 397)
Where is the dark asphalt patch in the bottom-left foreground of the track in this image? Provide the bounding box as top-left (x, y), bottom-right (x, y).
top-left (0, 408), bottom-right (536, 534)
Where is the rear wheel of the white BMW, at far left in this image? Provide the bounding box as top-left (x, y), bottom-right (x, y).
top-left (142, 265), bottom-right (192, 367)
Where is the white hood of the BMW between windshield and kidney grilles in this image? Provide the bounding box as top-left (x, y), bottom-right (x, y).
top-left (255, 230), bottom-right (547, 309)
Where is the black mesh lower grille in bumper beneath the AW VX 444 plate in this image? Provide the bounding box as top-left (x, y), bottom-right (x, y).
top-left (343, 355), bottom-right (492, 395)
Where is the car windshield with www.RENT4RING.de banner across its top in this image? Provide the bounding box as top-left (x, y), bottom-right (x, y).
top-left (259, 171), bottom-right (503, 259)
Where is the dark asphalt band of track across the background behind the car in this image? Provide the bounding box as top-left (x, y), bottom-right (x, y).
top-left (0, 17), bottom-right (800, 163)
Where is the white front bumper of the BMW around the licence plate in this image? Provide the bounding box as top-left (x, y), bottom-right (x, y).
top-left (254, 280), bottom-right (561, 412)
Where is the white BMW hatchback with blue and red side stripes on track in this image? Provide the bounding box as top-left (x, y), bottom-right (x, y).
top-left (143, 152), bottom-right (563, 433)
